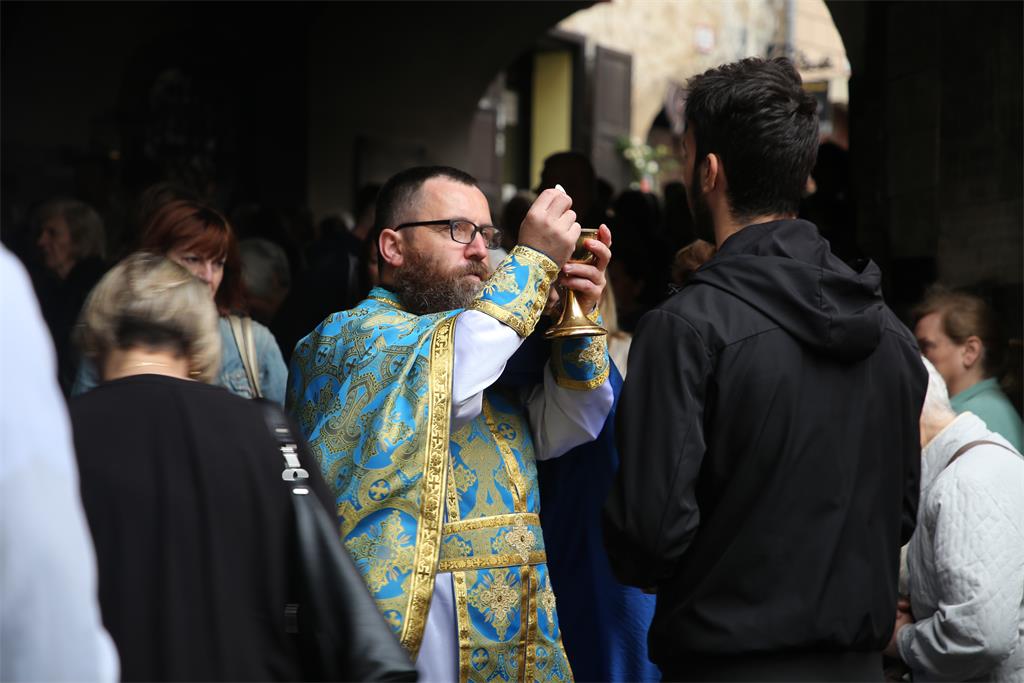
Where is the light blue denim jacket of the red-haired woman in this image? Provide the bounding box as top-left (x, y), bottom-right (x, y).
top-left (71, 317), bottom-right (288, 405)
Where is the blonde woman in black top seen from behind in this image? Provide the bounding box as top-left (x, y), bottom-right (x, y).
top-left (69, 252), bottom-right (330, 681)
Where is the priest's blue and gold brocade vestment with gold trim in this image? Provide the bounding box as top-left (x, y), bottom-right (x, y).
top-left (288, 247), bottom-right (608, 681)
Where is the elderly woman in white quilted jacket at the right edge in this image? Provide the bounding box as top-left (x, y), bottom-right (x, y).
top-left (886, 360), bottom-right (1024, 681)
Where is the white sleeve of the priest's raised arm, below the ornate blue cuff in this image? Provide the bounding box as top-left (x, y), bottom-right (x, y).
top-left (452, 310), bottom-right (522, 431)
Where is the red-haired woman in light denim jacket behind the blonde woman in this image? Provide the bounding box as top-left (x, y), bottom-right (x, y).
top-left (72, 201), bottom-right (288, 403)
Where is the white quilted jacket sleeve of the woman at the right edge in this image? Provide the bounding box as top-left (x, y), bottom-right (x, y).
top-left (897, 446), bottom-right (1024, 681)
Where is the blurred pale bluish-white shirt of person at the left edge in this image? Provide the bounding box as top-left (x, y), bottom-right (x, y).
top-left (0, 248), bottom-right (118, 681)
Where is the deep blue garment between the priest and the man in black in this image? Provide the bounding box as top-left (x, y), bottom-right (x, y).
top-left (537, 365), bottom-right (662, 681)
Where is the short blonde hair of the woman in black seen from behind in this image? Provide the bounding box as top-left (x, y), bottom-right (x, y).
top-left (76, 252), bottom-right (221, 383)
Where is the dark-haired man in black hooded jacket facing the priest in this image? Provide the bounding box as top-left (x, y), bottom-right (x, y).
top-left (604, 58), bottom-right (927, 680)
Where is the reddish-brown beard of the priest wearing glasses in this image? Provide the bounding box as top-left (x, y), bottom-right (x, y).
top-left (394, 251), bottom-right (487, 315)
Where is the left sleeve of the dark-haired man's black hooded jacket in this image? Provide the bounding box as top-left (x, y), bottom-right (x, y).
top-left (604, 309), bottom-right (711, 588)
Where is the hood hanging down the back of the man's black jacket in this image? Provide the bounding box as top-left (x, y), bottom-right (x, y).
top-left (687, 220), bottom-right (885, 361)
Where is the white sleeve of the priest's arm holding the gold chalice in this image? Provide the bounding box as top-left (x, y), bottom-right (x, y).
top-left (526, 364), bottom-right (615, 460)
